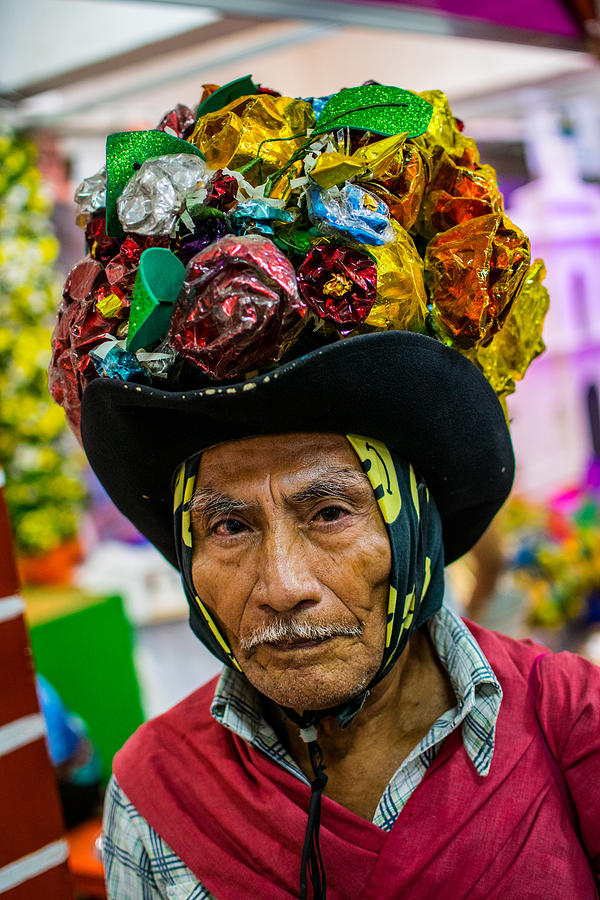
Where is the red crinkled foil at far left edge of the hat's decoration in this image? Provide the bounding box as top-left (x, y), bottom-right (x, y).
top-left (48, 257), bottom-right (121, 442)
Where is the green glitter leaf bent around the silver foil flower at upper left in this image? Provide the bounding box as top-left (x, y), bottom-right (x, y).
top-left (106, 131), bottom-right (204, 237)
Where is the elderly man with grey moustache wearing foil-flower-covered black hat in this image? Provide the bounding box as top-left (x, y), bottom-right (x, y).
top-left (51, 81), bottom-right (600, 900)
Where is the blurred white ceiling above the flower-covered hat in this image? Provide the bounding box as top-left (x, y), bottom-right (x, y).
top-left (0, 0), bottom-right (600, 144)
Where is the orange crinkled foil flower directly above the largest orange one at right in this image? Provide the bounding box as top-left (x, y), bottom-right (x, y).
top-left (416, 153), bottom-right (504, 240)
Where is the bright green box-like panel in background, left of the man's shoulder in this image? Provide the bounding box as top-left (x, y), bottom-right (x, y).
top-left (25, 589), bottom-right (144, 780)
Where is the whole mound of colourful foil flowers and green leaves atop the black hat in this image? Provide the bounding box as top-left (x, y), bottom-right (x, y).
top-left (50, 76), bottom-right (547, 428)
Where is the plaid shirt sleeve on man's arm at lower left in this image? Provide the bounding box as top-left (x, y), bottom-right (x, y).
top-left (102, 776), bottom-right (215, 900)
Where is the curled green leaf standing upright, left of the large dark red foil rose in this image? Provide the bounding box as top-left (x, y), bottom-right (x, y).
top-left (127, 247), bottom-right (185, 352)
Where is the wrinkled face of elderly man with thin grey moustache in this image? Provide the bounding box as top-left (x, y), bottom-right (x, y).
top-left (192, 434), bottom-right (391, 710)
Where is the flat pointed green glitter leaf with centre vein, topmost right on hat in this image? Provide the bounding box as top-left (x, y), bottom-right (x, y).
top-left (314, 84), bottom-right (433, 137)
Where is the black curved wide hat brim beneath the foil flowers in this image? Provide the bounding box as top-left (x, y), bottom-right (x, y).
top-left (81, 331), bottom-right (514, 565)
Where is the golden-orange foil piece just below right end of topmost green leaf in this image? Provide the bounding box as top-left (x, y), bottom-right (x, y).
top-left (364, 141), bottom-right (425, 231)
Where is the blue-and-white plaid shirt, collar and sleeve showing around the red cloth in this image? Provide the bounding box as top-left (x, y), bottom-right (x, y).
top-left (104, 607), bottom-right (502, 900)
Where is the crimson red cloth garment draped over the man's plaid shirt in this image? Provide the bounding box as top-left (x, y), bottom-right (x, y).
top-left (115, 624), bottom-right (600, 900)
